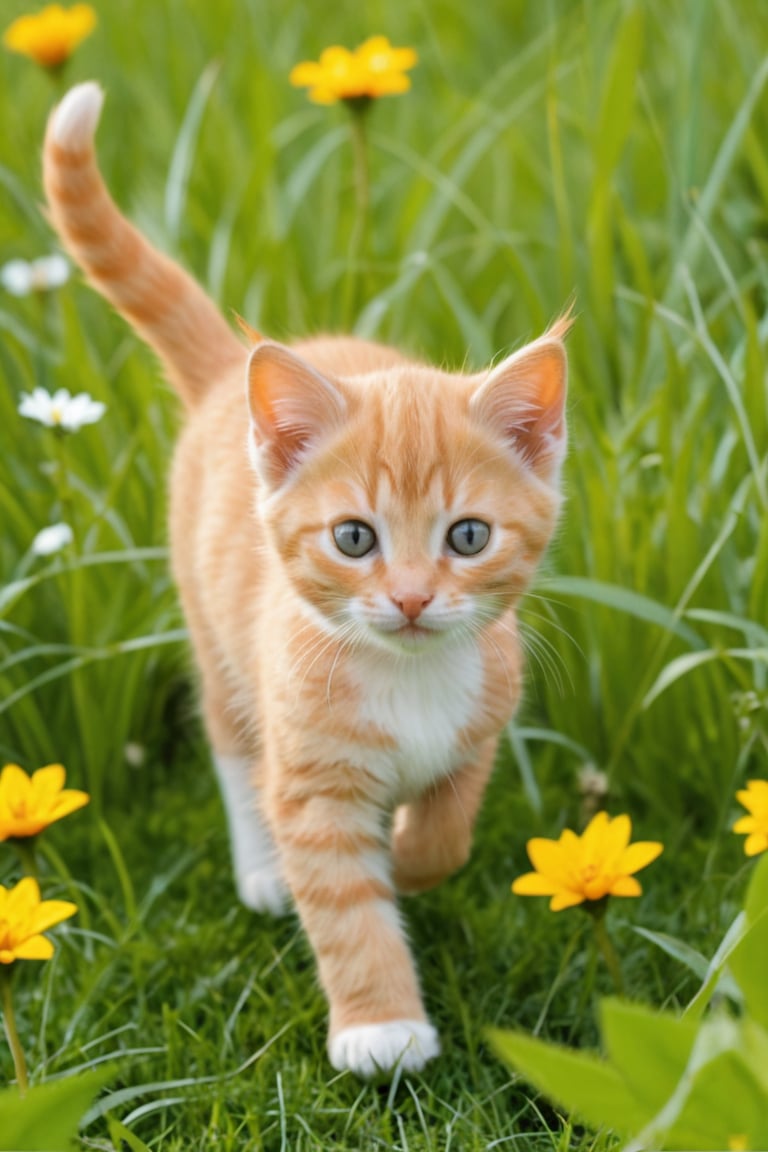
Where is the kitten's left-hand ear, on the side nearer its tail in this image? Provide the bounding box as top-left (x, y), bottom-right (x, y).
top-left (246, 341), bottom-right (347, 485)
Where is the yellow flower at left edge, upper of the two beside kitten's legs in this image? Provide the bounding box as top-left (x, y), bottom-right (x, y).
top-left (0, 764), bottom-right (90, 840)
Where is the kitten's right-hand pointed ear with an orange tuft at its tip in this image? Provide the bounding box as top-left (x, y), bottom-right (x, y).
top-left (470, 328), bottom-right (568, 479)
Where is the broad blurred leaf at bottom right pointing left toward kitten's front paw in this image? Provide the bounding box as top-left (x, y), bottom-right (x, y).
top-left (486, 1029), bottom-right (653, 1135)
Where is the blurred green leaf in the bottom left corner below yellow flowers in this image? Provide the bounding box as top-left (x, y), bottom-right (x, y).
top-left (0, 1068), bottom-right (112, 1152)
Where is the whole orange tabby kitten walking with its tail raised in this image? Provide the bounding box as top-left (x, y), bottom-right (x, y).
top-left (44, 83), bottom-right (570, 1076)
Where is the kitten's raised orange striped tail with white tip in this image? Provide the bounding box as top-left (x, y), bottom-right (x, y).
top-left (43, 83), bottom-right (245, 407)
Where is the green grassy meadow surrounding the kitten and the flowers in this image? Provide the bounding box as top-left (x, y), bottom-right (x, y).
top-left (0, 0), bottom-right (768, 1152)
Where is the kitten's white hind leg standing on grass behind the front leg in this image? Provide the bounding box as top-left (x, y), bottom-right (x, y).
top-left (213, 751), bottom-right (289, 916)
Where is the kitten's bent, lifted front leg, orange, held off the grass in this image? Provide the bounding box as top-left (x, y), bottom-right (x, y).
top-left (391, 737), bottom-right (497, 892)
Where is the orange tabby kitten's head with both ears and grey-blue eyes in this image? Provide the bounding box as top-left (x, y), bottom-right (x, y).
top-left (248, 320), bottom-right (569, 652)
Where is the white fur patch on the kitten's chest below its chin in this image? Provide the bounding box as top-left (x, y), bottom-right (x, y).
top-left (354, 643), bottom-right (482, 801)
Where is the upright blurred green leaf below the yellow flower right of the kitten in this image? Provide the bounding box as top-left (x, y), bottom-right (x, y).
top-left (600, 999), bottom-right (698, 1112)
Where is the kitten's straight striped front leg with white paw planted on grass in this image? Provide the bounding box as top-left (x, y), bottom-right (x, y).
top-left (268, 765), bottom-right (440, 1077)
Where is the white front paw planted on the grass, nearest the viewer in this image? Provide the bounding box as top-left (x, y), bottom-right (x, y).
top-left (328, 1020), bottom-right (440, 1078)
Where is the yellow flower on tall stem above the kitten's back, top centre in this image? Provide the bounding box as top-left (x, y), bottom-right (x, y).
top-left (289, 36), bottom-right (418, 104)
